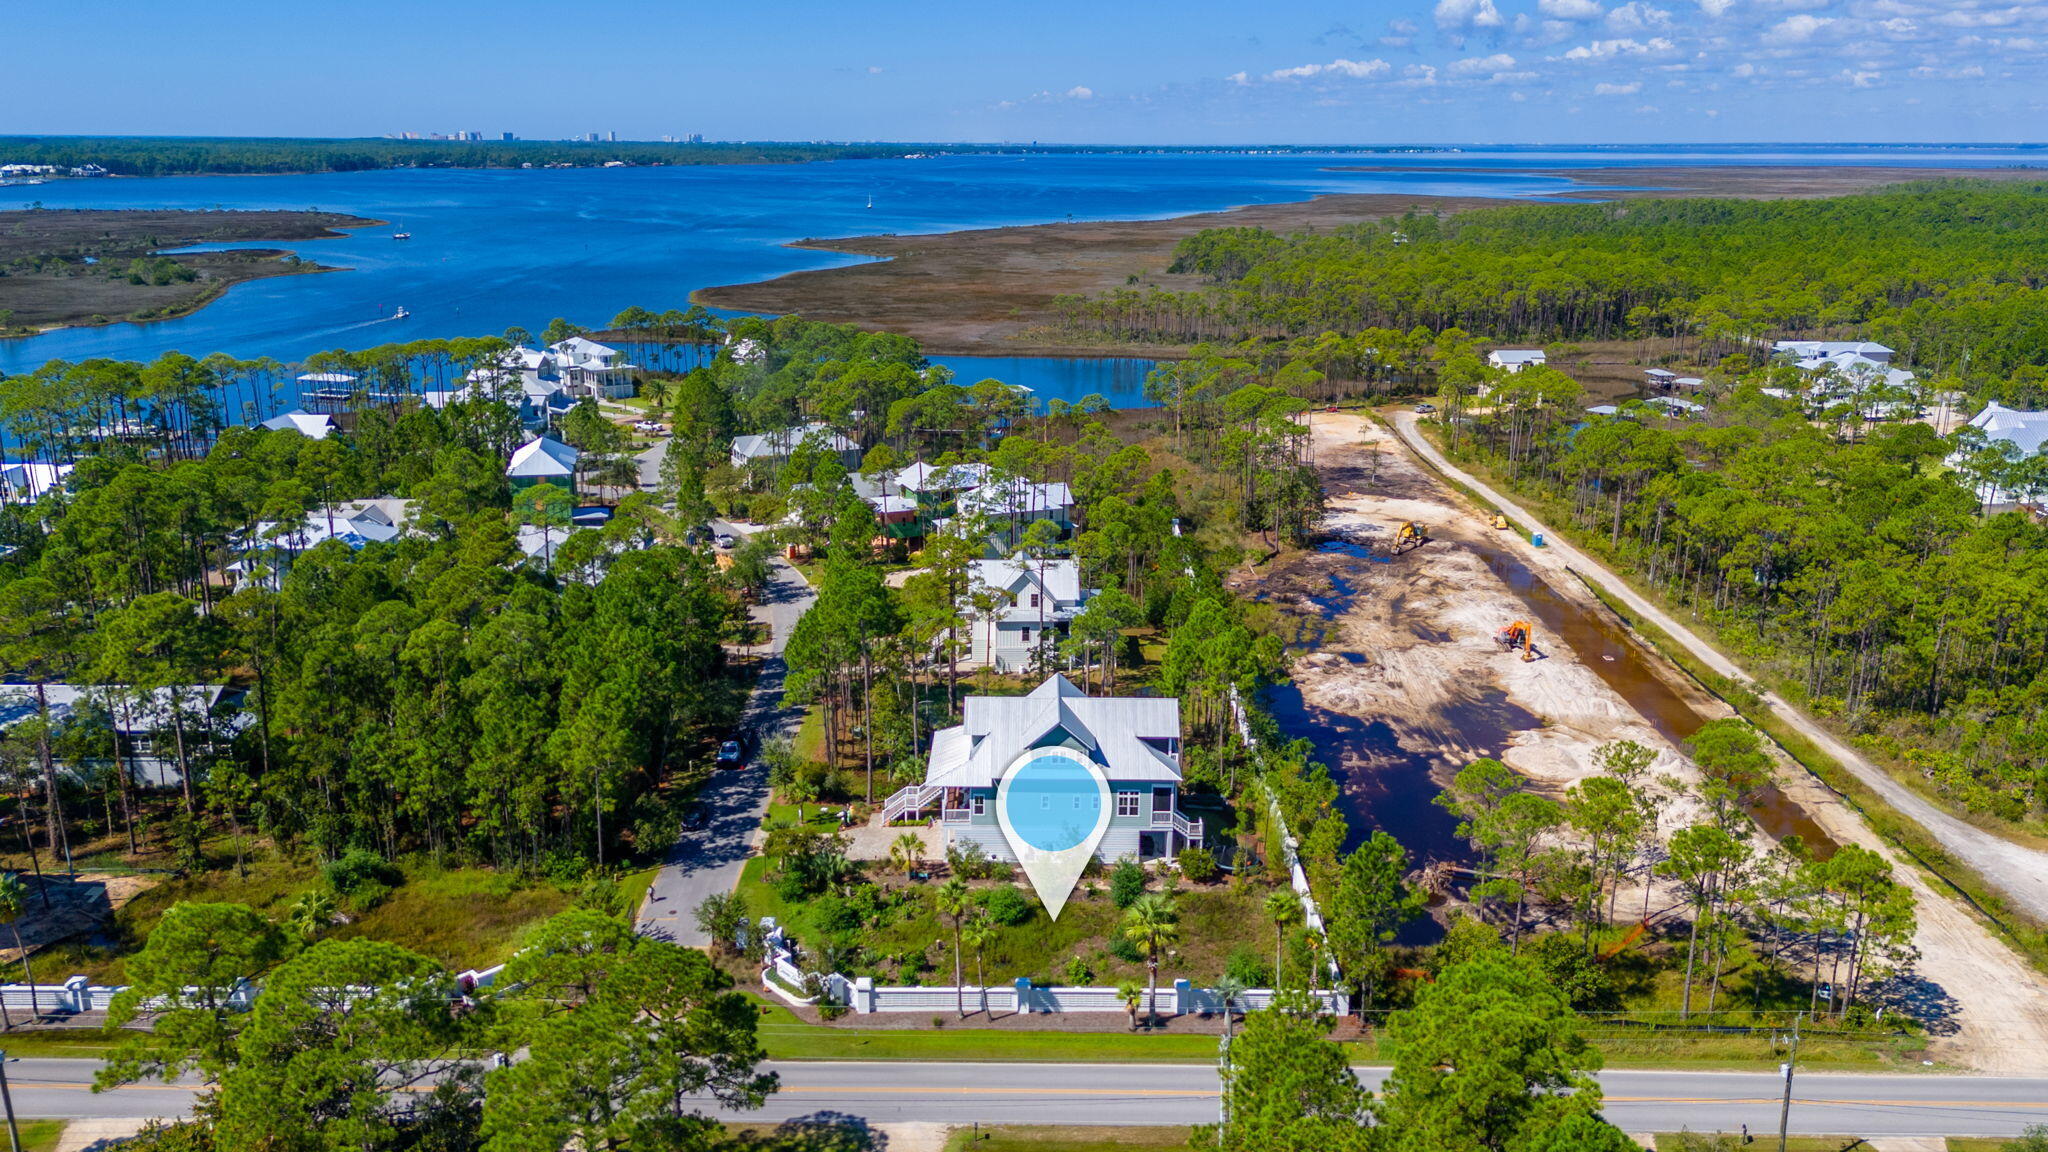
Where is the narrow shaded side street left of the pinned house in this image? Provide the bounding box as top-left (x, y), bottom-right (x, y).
top-left (639, 521), bottom-right (817, 947)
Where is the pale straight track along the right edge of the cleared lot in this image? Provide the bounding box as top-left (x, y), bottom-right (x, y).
top-left (1393, 410), bottom-right (2048, 918)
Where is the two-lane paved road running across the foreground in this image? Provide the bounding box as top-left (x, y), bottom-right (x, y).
top-left (8, 1060), bottom-right (2048, 1138)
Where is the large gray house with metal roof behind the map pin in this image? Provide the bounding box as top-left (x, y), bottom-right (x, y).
top-left (883, 676), bottom-right (1202, 863)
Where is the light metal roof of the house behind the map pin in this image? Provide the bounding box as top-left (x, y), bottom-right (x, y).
top-left (924, 676), bottom-right (1180, 787)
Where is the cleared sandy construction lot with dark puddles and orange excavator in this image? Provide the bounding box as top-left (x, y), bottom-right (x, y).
top-left (1286, 412), bottom-right (2048, 1074)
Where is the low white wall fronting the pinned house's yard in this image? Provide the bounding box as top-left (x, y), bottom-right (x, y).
top-left (760, 916), bottom-right (1352, 1017)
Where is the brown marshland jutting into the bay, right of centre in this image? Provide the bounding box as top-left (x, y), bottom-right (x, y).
top-left (690, 164), bottom-right (2048, 359)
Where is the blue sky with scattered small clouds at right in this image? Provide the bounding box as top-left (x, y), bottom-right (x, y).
top-left (0, 0), bottom-right (2048, 143)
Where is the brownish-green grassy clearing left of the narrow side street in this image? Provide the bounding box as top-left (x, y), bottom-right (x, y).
top-left (49, 857), bottom-right (577, 984)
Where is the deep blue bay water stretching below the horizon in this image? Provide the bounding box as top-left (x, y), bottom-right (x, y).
top-left (0, 148), bottom-right (2048, 406)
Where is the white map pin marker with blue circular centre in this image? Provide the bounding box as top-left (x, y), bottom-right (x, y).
top-left (995, 748), bottom-right (1112, 920)
